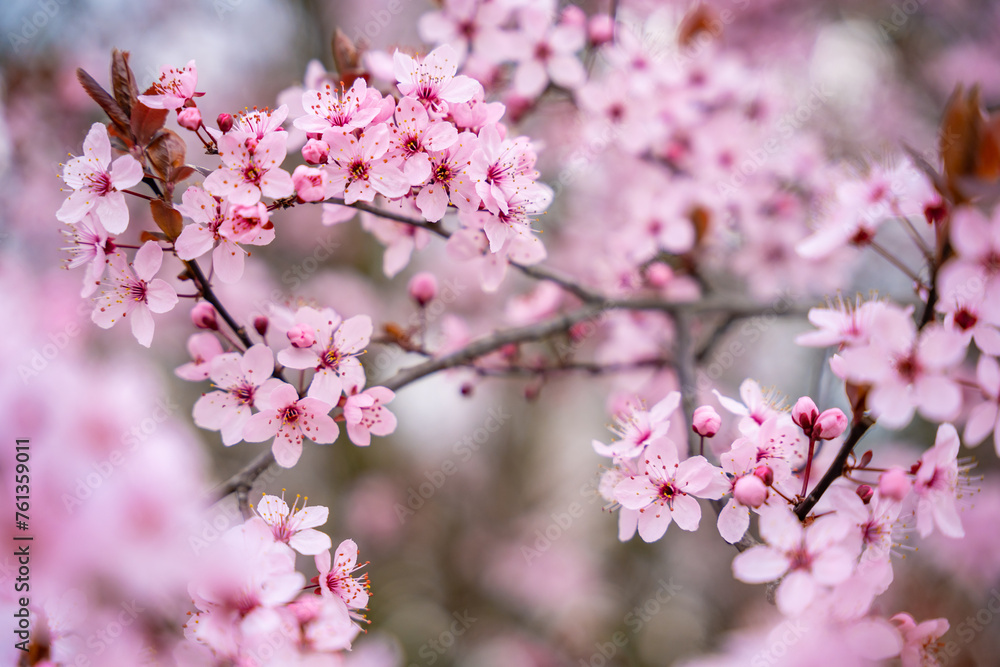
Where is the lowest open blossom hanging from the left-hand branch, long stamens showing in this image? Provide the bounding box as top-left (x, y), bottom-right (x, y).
top-left (91, 241), bottom-right (177, 347)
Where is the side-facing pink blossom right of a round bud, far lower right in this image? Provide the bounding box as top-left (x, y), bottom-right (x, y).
top-left (913, 424), bottom-right (966, 537)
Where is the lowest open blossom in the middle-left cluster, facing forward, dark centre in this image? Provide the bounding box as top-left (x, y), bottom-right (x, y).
top-left (243, 382), bottom-right (340, 468)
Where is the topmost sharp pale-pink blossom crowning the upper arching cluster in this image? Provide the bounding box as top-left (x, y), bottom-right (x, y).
top-left (392, 44), bottom-right (482, 113)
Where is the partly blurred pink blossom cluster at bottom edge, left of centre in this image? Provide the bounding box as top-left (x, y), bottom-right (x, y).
top-left (184, 495), bottom-right (368, 664)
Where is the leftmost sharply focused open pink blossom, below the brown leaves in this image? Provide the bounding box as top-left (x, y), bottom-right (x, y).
top-left (56, 123), bottom-right (142, 234)
